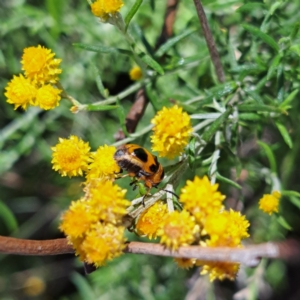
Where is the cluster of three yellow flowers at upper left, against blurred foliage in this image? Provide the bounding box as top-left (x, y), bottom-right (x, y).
top-left (5, 45), bottom-right (62, 110)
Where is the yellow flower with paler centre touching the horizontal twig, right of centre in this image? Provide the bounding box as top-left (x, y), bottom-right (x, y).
top-left (157, 210), bottom-right (199, 250)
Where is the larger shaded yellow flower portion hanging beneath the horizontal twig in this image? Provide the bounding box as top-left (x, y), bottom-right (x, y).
top-left (196, 261), bottom-right (240, 281)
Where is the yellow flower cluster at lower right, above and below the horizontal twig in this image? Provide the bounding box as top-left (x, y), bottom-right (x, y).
top-left (136, 176), bottom-right (249, 280)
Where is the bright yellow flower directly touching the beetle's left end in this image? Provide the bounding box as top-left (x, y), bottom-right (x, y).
top-left (86, 145), bottom-right (121, 182)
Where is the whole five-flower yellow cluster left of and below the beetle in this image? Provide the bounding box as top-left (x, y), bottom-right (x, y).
top-left (52, 135), bottom-right (130, 267)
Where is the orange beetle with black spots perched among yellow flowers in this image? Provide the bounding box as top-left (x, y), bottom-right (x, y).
top-left (114, 144), bottom-right (165, 190)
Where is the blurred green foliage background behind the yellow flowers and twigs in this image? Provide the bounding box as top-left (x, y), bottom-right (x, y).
top-left (0, 0), bottom-right (300, 300)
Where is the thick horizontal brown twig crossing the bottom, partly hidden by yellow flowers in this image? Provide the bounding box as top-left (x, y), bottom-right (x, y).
top-left (0, 236), bottom-right (300, 267)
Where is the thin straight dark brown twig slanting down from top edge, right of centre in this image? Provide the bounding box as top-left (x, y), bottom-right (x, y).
top-left (194, 0), bottom-right (225, 82)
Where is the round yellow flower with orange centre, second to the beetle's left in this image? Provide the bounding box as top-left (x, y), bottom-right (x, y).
top-left (51, 135), bottom-right (90, 177)
